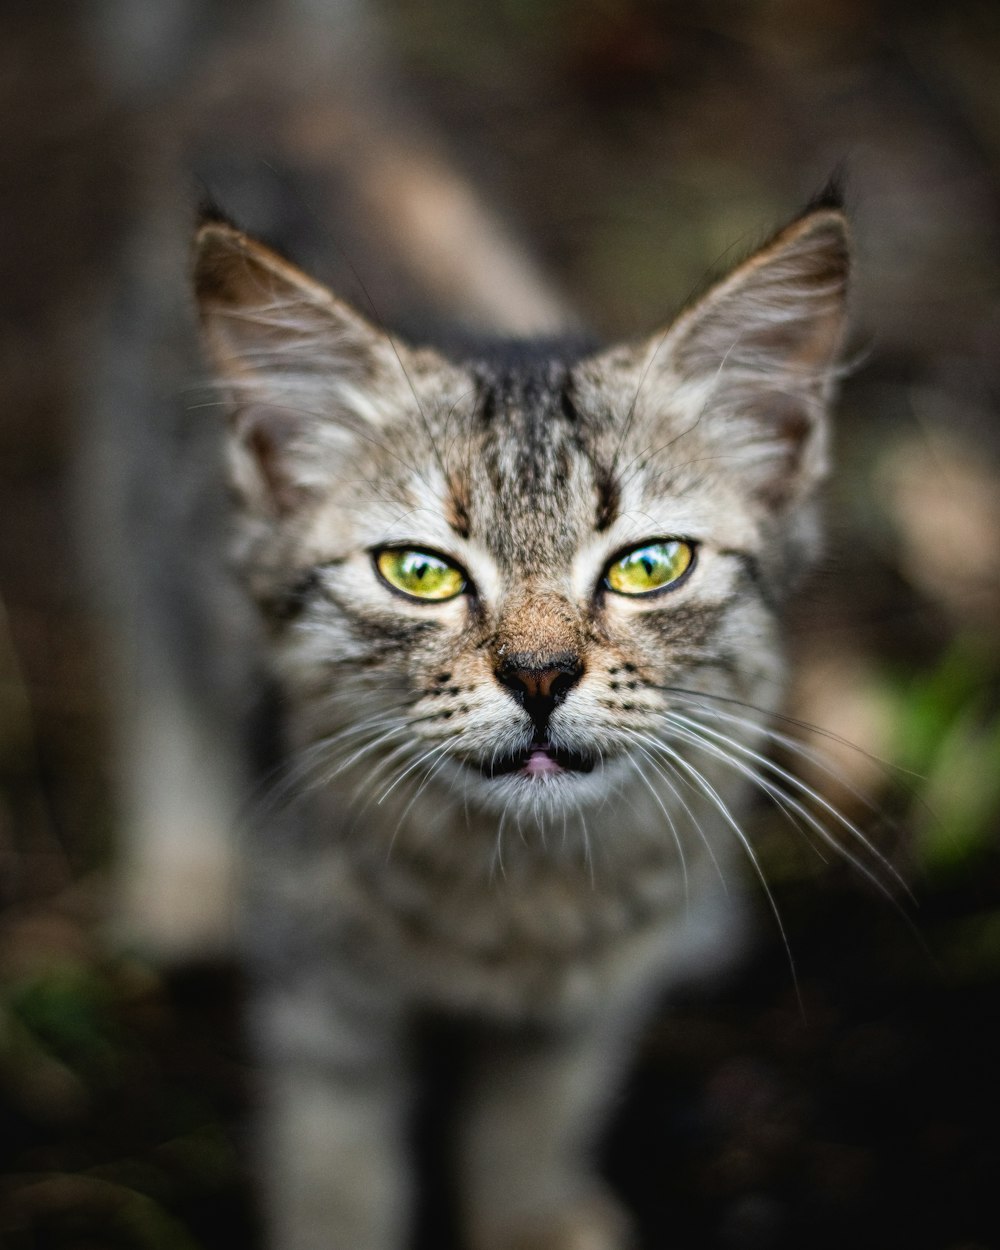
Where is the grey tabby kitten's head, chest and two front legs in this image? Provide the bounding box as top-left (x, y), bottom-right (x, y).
top-left (195, 196), bottom-right (850, 1250)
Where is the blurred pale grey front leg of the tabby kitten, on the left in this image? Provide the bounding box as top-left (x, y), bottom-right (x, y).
top-left (253, 988), bottom-right (411, 1250)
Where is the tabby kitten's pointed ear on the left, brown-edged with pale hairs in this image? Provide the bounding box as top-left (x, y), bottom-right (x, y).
top-left (194, 220), bottom-right (411, 515)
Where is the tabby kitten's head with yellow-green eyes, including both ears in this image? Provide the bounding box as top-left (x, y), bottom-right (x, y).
top-left (196, 206), bottom-right (849, 811)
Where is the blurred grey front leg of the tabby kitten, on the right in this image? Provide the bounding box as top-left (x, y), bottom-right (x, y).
top-left (459, 1018), bottom-right (633, 1250)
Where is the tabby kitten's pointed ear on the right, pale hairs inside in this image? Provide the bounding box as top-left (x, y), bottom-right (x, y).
top-left (590, 206), bottom-right (850, 508)
